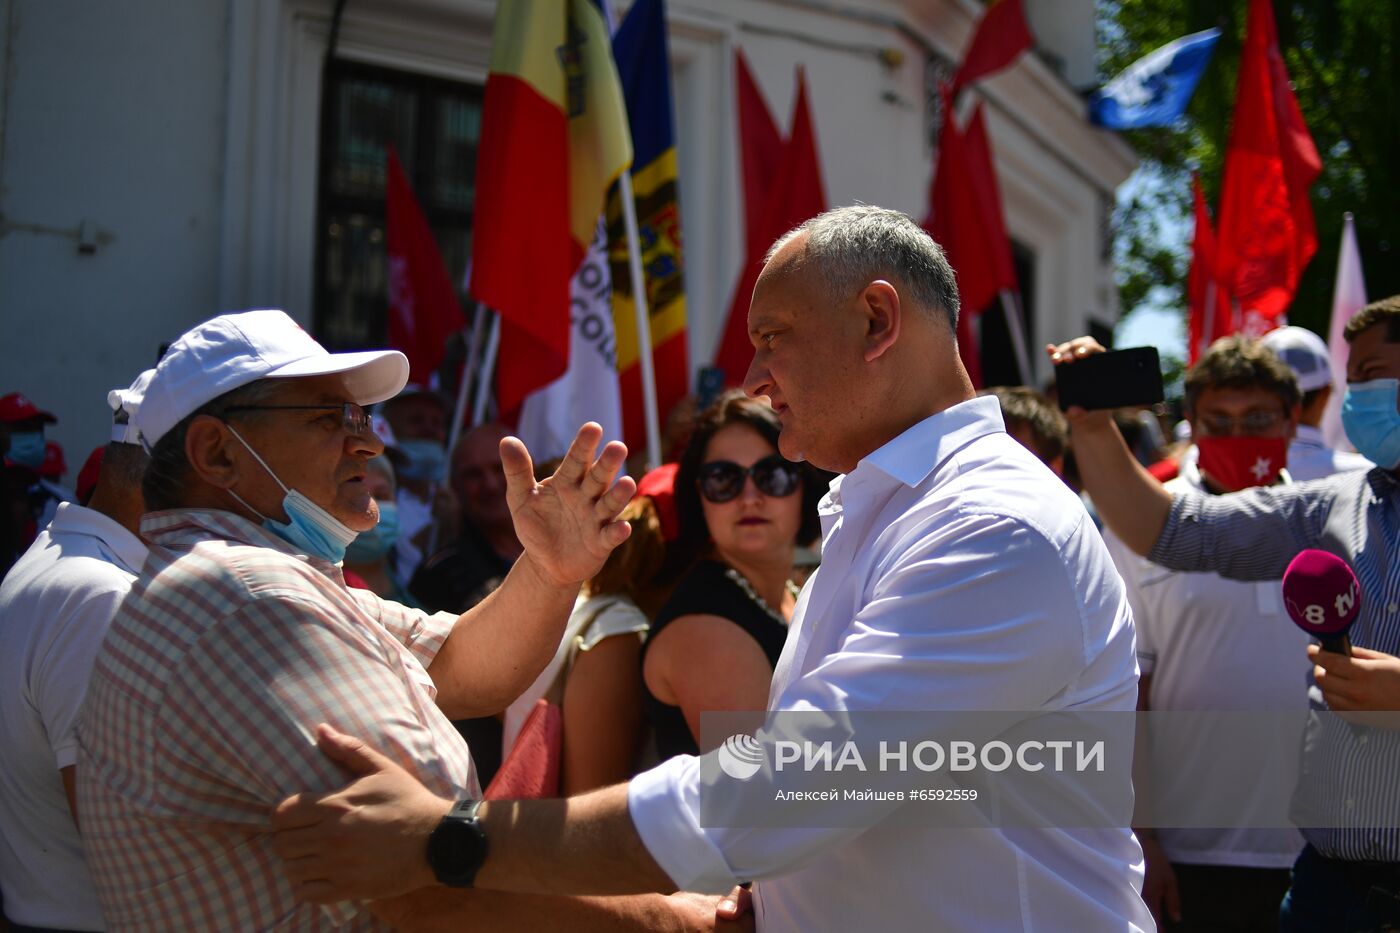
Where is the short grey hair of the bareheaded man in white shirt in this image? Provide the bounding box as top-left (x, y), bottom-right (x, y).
top-left (763, 205), bottom-right (959, 333)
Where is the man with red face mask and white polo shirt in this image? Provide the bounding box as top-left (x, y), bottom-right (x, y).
top-left (1103, 336), bottom-right (1309, 933)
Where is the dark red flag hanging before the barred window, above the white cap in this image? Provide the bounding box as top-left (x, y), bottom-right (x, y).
top-left (384, 146), bottom-right (463, 385)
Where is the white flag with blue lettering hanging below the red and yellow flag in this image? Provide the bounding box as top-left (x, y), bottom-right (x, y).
top-left (517, 220), bottom-right (622, 464)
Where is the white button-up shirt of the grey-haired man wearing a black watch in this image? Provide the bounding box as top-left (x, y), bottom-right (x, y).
top-left (629, 398), bottom-right (1152, 933)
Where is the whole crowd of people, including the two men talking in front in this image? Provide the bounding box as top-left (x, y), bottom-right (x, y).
top-left (0, 206), bottom-right (1400, 932)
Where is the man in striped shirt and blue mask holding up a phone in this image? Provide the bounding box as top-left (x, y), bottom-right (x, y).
top-left (1049, 296), bottom-right (1400, 933)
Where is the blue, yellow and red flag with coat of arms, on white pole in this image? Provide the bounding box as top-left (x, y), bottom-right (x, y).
top-left (608, 0), bottom-right (690, 455)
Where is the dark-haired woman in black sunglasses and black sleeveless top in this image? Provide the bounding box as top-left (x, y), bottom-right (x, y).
top-left (643, 391), bottom-right (819, 758)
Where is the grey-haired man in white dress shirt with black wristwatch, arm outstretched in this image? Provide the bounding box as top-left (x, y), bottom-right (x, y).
top-left (274, 206), bottom-right (1151, 933)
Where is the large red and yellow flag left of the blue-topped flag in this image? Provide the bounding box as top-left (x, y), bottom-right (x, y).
top-left (472, 0), bottom-right (631, 415)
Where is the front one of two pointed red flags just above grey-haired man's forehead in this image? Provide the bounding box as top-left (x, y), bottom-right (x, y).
top-left (714, 67), bottom-right (826, 385)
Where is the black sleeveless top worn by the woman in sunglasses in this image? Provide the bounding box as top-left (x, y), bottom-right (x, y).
top-left (641, 560), bottom-right (788, 759)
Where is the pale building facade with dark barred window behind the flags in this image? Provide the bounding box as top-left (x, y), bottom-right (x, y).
top-left (0, 0), bottom-right (1135, 462)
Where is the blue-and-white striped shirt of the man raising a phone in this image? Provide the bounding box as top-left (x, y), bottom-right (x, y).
top-left (1148, 468), bottom-right (1400, 862)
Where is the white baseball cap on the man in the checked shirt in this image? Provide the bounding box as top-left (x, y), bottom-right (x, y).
top-left (132, 310), bottom-right (409, 448)
